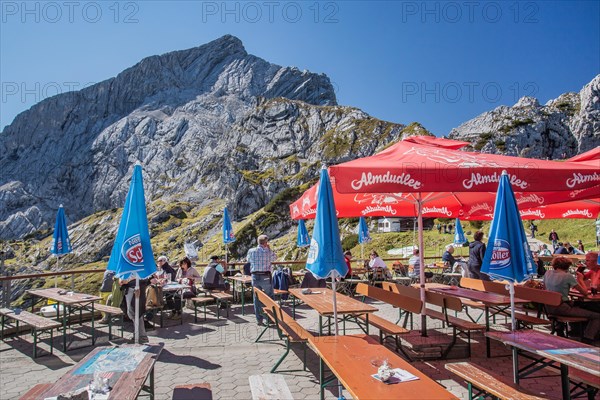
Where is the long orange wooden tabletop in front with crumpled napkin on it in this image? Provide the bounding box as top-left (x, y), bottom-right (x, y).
top-left (309, 335), bottom-right (457, 400)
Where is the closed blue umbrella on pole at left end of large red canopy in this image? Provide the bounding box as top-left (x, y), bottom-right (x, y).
top-left (306, 167), bottom-right (348, 399)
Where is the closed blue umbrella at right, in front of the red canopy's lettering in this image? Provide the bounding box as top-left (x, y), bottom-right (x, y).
top-left (481, 171), bottom-right (536, 330)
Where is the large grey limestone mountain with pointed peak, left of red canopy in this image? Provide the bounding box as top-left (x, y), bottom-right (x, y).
top-left (0, 36), bottom-right (402, 239)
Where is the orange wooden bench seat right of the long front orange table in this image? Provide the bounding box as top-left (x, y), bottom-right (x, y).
top-left (446, 362), bottom-right (543, 400)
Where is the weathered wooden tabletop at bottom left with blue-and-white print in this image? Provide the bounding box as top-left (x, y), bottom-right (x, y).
top-left (37, 345), bottom-right (162, 400)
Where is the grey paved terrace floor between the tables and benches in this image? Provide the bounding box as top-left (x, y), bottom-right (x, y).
top-left (0, 296), bottom-right (580, 400)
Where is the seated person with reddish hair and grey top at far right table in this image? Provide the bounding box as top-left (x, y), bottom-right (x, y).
top-left (544, 257), bottom-right (600, 343)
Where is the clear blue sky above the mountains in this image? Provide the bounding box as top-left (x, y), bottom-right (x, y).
top-left (0, 0), bottom-right (600, 136)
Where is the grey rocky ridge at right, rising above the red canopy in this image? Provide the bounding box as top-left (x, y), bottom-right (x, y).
top-left (449, 75), bottom-right (600, 159)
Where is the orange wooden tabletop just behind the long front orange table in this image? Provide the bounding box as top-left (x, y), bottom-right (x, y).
top-left (289, 288), bottom-right (377, 315)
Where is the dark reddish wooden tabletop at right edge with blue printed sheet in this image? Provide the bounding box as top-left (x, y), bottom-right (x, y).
top-left (485, 329), bottom-right (600, 377)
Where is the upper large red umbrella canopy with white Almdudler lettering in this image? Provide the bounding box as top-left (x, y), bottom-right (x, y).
top-left (329, 140), bottom-right (600, 193)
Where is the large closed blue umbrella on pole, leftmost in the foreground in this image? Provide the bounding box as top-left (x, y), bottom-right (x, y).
top-left (106, 164), bottom-right (156, 343)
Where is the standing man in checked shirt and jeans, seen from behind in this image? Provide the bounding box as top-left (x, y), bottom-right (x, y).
top-left (247, 235), bottom-right (277, 325)
